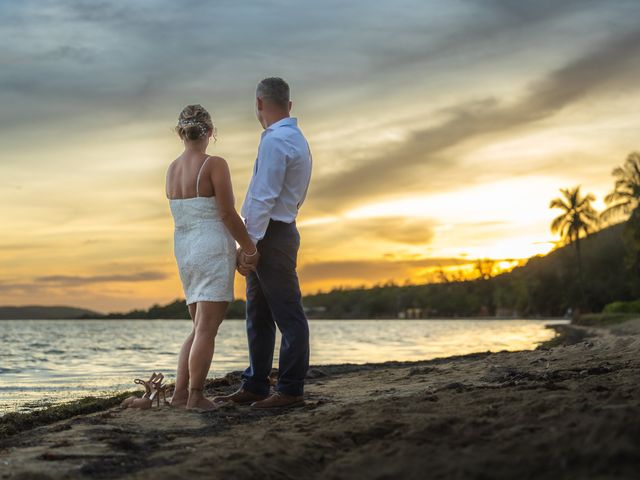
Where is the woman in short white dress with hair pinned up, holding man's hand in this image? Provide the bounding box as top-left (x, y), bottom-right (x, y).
top-left (166, 105), bottom-right (260, 410)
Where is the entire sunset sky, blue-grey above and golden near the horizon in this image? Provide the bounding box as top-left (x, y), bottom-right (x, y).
top-left (0, 0), bottom-right (640, 312)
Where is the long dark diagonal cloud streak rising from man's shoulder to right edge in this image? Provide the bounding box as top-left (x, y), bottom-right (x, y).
top-left (310, 29), bottom-right (640, 211)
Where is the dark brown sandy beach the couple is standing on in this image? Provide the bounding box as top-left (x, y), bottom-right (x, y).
top-left (0, 319), bottom-right (640, 479)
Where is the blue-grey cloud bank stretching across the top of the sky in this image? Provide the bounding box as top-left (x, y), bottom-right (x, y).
top-left (0, 0), bottom-right (625, 133)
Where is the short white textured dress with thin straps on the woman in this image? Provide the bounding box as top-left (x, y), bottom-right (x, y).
top-left (169, 155), bottom-right (236, 305)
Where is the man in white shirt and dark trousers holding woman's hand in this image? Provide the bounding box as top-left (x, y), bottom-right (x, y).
top-left (214, 78), bottom-right (311, 409)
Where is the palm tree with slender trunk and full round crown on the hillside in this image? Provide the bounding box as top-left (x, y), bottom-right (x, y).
top-left (549, 185), bottom-right (599, 304)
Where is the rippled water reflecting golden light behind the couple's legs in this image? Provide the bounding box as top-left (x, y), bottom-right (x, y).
top-left (0, 320), bottom-right (563, 413)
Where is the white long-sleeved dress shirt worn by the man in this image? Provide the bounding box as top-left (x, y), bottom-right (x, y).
top-left (241, 117), bottom-right (311, 243)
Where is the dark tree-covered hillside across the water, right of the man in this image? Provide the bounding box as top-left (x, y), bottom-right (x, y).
top-left (305, 224), bottom-right (639, 318)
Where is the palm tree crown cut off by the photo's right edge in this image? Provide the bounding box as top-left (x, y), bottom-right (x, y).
top-left (601, 152), bottom-right (640, 221)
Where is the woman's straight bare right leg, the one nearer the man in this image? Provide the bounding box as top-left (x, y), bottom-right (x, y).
top-left (187, 302), bottom-right (228, 409)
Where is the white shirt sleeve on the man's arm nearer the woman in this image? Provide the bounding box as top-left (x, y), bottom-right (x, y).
top-left (243, 135), bottom-right (288, 243)
